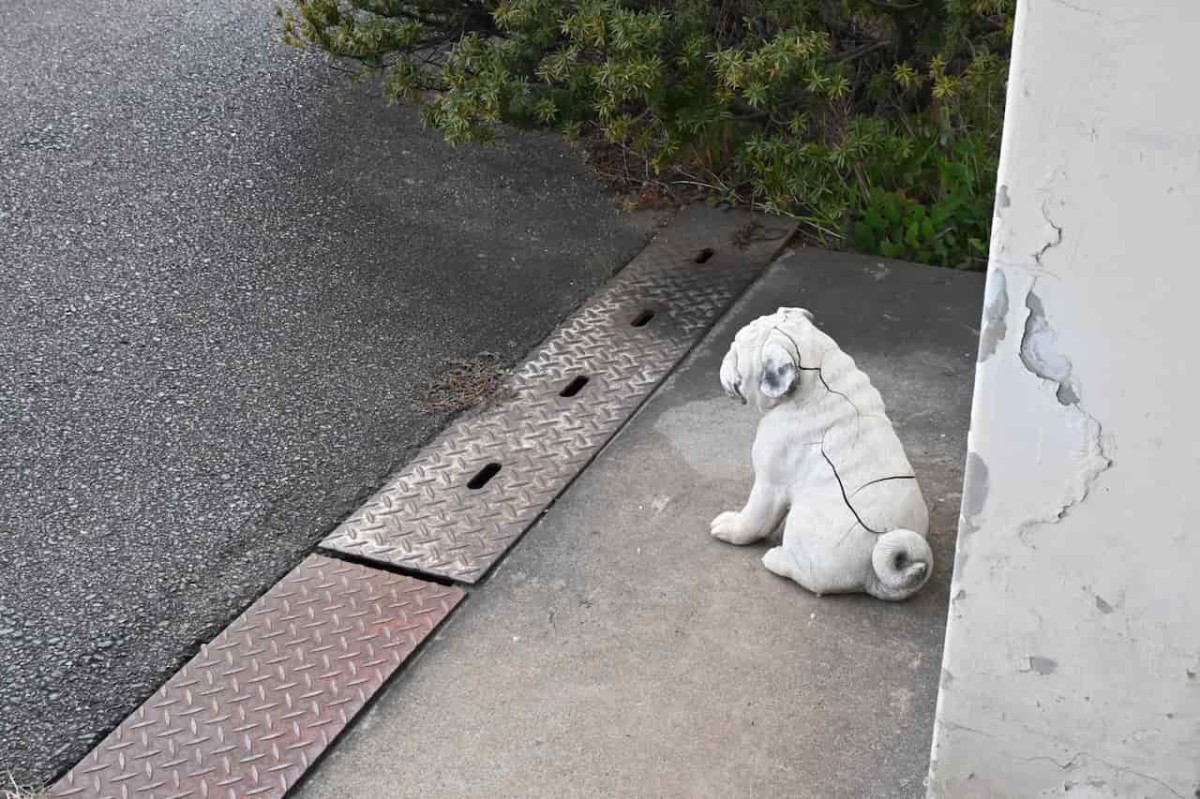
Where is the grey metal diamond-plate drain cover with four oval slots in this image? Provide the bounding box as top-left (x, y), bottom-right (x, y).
top-left (322, 206), bottom-right (792, 583)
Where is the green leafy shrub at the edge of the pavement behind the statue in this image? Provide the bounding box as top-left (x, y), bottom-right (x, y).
top-left (280, 0), bottom-right (1015, 268)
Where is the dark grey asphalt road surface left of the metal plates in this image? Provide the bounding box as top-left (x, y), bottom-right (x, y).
top-left (0, 0), bottom-right (644, 782)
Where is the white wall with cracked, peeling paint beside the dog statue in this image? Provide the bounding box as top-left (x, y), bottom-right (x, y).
top-left (930, 0), bottom-right (1200, 799)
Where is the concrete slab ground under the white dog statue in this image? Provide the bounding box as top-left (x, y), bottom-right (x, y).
top-left (296, 251), bottom-right (983, 799)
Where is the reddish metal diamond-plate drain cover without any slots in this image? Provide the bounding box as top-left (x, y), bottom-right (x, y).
top-left (50, 555), bottom-right (463, 799)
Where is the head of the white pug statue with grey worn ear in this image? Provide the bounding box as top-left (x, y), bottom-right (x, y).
top-left (721, 308), bottom-right (821, 413)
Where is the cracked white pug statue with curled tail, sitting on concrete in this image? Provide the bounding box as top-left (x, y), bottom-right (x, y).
top-left (712, 308), bottom-right (934, 600)
